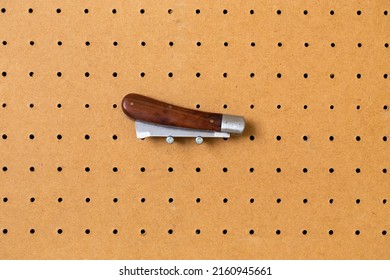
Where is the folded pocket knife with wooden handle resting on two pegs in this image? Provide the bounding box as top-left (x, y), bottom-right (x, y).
top-left (122, 93), bottom-right (245, 144)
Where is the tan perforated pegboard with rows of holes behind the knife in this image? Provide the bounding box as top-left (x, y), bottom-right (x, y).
top-left (0, 0), bottom-right (390, 259)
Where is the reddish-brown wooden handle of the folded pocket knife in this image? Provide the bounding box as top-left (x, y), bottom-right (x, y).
top-left (122, 93), bottom-right (222, 131)
